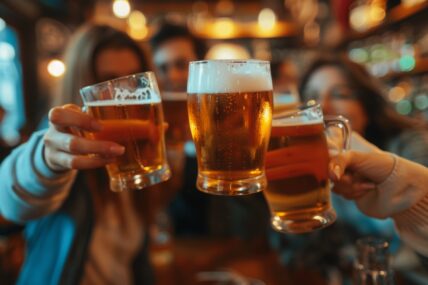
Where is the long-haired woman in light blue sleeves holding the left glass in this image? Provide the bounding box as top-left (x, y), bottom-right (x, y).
top-left (0, 25), bottom-right (154, 284)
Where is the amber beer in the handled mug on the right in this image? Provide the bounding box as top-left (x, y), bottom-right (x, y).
top-left (265, 118), bottom-right (334, 233)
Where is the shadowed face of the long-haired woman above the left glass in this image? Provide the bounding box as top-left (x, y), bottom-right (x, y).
top-left (95, 48), bottom-right (143, 82)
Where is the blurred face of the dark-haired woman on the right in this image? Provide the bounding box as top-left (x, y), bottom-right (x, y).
top-left (303, 66), bottom-right (367, 134)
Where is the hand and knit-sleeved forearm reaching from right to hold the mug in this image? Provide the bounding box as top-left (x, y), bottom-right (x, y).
top-left (330, 148), bottom-right (428, 256)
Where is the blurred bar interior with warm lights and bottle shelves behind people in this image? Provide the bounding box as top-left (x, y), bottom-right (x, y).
top-left (0, 0), bottom-right (428, 145)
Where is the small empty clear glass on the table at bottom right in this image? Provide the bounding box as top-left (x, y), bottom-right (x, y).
top-left (353, 237), bottom-right (394, 285)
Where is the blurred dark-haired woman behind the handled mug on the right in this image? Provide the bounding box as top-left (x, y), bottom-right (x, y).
top-left (270, 52), bottom-right (428, 278)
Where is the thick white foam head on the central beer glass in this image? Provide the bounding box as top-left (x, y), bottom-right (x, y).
top-left (187, 60), bottom-right (272, 94)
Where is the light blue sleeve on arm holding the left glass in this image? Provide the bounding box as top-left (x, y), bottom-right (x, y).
top-left (0, 130), bottom-right (76, 223)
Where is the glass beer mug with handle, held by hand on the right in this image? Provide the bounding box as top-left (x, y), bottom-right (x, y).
top-left (264, 105), bottom-right (350, 233)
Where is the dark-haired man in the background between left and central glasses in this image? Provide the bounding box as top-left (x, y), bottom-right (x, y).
top-left (150, 20), bottom-right (209, 235)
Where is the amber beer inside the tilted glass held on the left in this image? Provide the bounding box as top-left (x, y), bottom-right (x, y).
top-left (87, 102), bottom-right (165, 179)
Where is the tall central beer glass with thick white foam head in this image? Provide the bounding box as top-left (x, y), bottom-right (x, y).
top-left (187, 60), bottom-right (272, 195)
